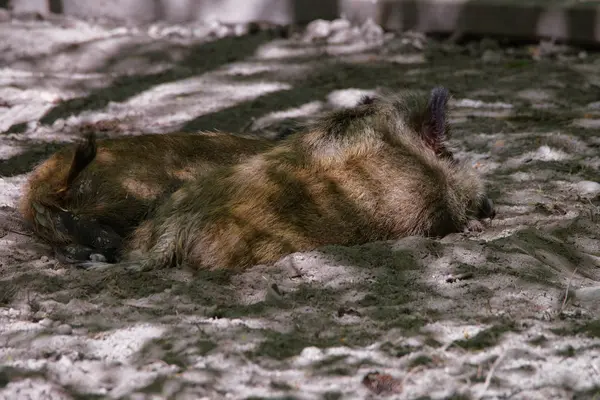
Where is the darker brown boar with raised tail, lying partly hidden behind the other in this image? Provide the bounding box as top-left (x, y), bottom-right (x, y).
top-left (19, 133), bottom-right (273, 261)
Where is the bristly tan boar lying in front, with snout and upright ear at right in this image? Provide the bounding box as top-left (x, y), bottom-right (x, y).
top-left (125, 88), bottom-right (493, 269)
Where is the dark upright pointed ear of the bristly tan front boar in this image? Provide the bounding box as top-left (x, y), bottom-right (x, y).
top-left (420, 86), bottom-right (450, 153)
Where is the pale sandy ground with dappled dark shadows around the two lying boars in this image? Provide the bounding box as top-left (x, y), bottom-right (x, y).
top-left (0, 12), bottom-right (600, 399)
